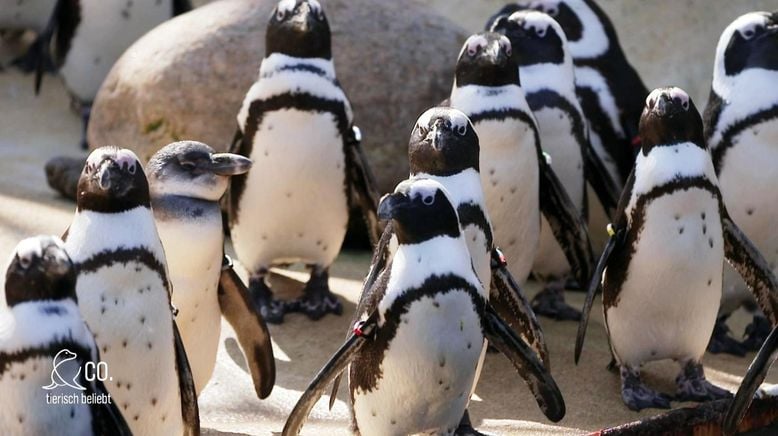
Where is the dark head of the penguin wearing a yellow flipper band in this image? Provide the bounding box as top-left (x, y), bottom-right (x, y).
top-left (639, 86), bottom-right (705, 156)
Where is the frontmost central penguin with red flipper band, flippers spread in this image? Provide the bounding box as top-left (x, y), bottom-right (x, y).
top-left (283, 178), bottom-right (565, 435)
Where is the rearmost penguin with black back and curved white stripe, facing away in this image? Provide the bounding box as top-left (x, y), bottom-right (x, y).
top-left (490, 0), bottom-right (648, 188)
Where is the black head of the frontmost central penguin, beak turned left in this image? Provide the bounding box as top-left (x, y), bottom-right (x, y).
top-left (378, 177), bottom-right (460, 244)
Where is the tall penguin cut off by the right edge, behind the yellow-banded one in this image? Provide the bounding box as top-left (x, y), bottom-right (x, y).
top-left (703, 12), bottom-right (778, 356)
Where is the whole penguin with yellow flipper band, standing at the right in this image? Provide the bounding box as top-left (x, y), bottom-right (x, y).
top-left (575, 87), bottom-right (778, 410)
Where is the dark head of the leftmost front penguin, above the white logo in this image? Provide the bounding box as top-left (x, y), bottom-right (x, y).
top-left (5, 236), bottom-right (76, 307)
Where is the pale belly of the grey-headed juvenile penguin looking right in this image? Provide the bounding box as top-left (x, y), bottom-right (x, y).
top-left (157, 220), bottom-right (224, 393)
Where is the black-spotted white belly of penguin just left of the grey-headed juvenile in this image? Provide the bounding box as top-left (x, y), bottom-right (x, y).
top-left (76, 261), bottom-right (183, 434)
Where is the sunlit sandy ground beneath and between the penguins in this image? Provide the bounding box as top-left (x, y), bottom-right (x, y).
top-left (0, 64), bottom-right (778, 435)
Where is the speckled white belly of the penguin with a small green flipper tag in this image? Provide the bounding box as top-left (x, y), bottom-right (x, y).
top-left (475, 120), bottom-right (540, 283)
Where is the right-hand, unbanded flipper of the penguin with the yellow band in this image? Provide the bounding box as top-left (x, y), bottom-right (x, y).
top-left (721, 213), bottom-right (778, 327)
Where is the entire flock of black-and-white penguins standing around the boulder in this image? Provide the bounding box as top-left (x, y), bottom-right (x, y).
top-left (0, 0), bottom-right (778, 435)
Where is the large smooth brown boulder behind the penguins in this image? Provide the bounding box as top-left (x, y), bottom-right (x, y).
top-left (88, 0), bottom-right (467, 192)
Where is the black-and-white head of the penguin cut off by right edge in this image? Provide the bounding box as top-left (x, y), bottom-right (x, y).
top-left (714, 12), bottom-right (778, 80)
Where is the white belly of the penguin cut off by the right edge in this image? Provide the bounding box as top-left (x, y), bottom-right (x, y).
top-left (719, 119), bottom-right (778, 313)
